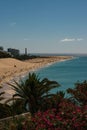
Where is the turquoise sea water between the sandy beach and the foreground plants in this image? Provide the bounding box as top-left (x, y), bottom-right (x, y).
top-left (36, 57), bottom-right (87, 93)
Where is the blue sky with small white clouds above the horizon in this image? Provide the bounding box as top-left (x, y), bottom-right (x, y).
top-left (0, 0), bottom-right (87, 53)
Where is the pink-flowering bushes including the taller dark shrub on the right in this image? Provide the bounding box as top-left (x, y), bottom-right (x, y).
top-left (2, 81), bottom-right (87, 130)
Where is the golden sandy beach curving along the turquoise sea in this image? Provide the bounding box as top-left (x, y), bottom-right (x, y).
top-left (0, 56), bottom-right (73, 99)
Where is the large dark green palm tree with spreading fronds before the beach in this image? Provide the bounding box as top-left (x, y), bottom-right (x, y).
top-left (9, 73), bottom-right (60, 114)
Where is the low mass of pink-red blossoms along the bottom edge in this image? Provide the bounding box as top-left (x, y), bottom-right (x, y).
top-left (25, 101), bottom-right (87, 130)
